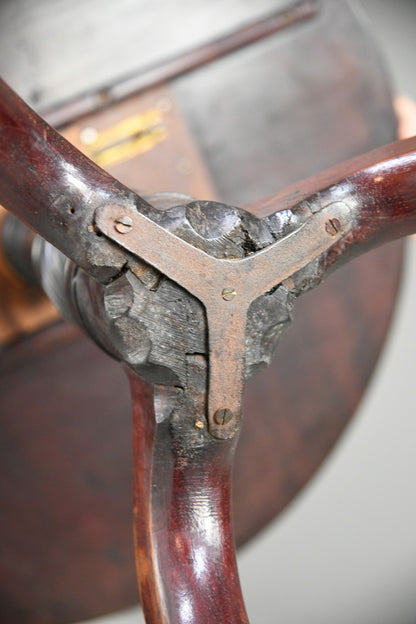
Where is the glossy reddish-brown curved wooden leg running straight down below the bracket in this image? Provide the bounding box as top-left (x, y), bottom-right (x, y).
top-left (128, 364), bottom-right (248, 624)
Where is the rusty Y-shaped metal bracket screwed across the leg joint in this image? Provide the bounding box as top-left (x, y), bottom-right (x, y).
top-left (95, 202), bottom-right (352, 439)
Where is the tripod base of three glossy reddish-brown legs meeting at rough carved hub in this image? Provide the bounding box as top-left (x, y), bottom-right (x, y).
top-left (4, 83), bottom-right (416, 624)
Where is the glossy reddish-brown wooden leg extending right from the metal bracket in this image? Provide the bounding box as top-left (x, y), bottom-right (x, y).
top-left (247, 137), bottom-right (416, 268)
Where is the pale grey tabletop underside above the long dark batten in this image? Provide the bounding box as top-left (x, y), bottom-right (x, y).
top-left (0, 0), bottom-right (302, 110)
